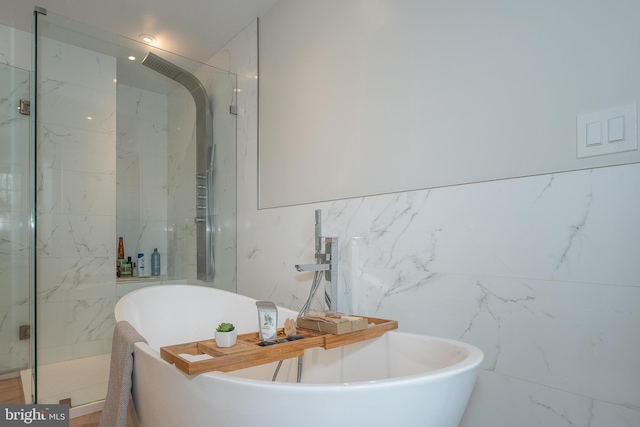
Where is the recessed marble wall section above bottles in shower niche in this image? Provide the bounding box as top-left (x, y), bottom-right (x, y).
top-left (114, 84), bottom-right (168, 276)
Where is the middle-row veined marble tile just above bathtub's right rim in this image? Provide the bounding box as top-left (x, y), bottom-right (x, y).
top-left (358, 268), bottom-right (640, 409)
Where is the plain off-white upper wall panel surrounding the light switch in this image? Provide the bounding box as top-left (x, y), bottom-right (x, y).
top-left (259, 0), bottom-right (640, 208)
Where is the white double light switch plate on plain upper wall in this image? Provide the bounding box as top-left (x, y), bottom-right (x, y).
top-left (576, 103), bottom-right (638, 159)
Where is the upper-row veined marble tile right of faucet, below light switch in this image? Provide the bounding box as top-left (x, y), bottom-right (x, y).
top-left (352, 165), bottom-right (640, 285)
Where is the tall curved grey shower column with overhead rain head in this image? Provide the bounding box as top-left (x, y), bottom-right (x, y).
top-left (142, 52), bottom-right (215, 282)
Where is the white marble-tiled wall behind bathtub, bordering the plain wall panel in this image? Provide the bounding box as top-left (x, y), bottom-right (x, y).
top-left (212, 15), bottom-right (640, 427)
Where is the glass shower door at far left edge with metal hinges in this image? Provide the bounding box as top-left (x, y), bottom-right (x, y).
top-left (0, 64), bottom-right (33, 386)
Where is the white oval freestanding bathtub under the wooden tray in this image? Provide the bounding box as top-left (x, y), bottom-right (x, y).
top-left (115, 285), bottom-right (483, 427)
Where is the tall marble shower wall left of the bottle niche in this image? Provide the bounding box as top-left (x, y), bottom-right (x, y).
top-left (36, 38), bottom-right (116, 366)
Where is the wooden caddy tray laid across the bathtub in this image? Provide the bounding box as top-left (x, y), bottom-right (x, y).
top-left (160, 317), bottom-right (398, 375)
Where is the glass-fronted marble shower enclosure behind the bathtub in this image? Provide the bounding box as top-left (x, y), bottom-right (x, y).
top-left (34, 11), bottom-right (236, 407)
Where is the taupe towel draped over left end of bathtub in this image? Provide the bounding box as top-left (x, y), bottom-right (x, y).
top-left (99, 321), bottom-right (147, 427)
